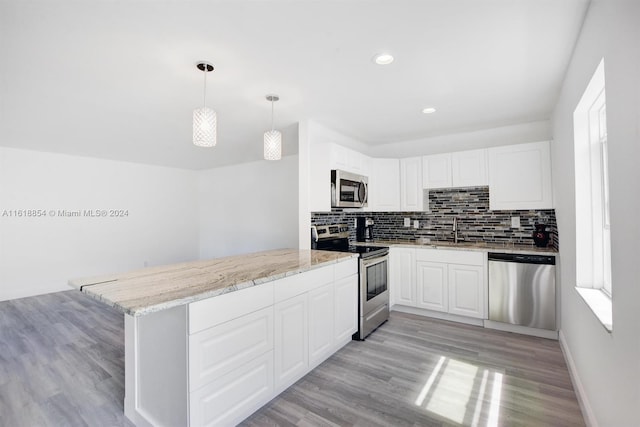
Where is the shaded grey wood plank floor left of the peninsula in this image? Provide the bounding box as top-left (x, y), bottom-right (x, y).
top-left (0, 291), bottom-right (133, 427)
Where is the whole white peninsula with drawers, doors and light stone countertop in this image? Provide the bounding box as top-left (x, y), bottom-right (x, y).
top-left (69, 249), bottom-right (358, 426)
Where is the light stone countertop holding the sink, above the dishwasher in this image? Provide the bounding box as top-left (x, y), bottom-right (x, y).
top-left (356, 239), bottom-right (558, 256)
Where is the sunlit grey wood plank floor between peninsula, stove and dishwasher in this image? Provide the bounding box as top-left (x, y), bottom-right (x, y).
top-left (242, 312), bottom-right (585, 427)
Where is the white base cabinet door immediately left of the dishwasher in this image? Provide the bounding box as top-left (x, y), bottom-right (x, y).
top-left (448, 264), bottom-right (487, 319)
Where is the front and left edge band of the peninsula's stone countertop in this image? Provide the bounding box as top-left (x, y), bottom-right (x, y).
top-left (74, 252), bottom-right (358, 317)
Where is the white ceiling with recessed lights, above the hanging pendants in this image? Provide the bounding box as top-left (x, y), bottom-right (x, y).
top-left (0, 0), bottom-right (589, 169)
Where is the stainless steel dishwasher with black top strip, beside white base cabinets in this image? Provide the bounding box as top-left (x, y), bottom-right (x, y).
top-left (489, 252), bottom-right (556, 331)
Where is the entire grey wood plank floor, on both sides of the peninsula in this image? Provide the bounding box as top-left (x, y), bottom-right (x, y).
top-left (0, 291), bottom-right (584, 427)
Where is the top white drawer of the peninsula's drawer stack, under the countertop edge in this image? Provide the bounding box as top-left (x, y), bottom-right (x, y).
top-left (189, 283), bottom-right (273, 334)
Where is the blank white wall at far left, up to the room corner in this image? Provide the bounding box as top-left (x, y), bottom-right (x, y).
top-left (0, 147), bottom-right (198, 300)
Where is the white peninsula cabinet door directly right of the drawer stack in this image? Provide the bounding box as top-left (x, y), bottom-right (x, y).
top-left (274, 294), bottom-right (309, 392)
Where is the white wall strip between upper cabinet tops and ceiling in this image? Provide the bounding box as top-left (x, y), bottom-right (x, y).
top-left (367, 121), bottom-right (551, 158)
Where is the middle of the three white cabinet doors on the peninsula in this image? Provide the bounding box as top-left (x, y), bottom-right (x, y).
top-left (309, 283), bottom-right (335, 366)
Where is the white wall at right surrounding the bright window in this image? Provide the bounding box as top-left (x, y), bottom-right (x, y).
top-left (552, 0), bottom-right (640, 426)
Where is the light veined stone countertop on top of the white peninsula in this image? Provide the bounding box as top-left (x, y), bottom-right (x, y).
top-left (69, 249), bottom-right (357, 316)
